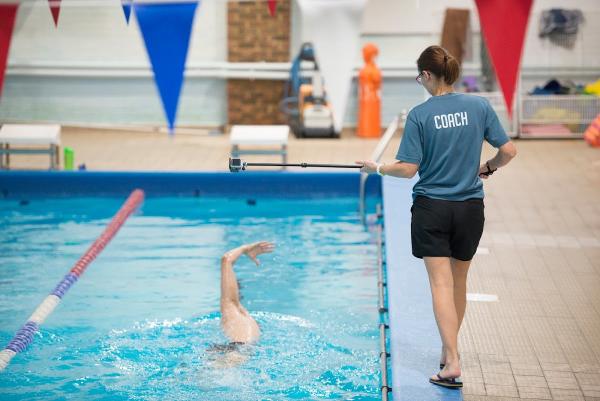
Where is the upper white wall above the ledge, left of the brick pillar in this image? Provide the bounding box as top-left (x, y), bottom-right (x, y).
top-left (9, 0), bottom-right (227, 68)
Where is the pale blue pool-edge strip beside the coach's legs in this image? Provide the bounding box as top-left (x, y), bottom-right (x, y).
top-left (382, 177), bottom-right (462, 401)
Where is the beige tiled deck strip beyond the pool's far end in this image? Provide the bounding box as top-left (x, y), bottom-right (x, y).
top-left (1, 127), bottom-right (399, 171)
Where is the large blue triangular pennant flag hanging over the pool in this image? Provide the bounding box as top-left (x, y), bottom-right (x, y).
top-left (133, 2), bottom-right (198, 134)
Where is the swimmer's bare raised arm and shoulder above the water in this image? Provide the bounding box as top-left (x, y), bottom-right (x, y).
top-left (221, 241), bottom-right (275, 348)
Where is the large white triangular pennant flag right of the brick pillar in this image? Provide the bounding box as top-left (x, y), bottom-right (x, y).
top-left (299, 0), bottom-right (367, 133)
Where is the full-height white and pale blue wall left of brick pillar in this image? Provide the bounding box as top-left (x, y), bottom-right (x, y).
top-left (0, 0), bottom-right (227, 126)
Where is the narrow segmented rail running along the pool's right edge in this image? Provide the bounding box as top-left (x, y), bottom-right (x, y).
top-left (376, 205), bottom-right (392, 401)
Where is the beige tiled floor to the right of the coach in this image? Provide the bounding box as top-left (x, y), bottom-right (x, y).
top-left (460, 141), bottom-right (600, 401)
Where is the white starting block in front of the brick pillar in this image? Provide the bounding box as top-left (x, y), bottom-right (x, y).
top-left (230, 125), bottom-right (290, 164)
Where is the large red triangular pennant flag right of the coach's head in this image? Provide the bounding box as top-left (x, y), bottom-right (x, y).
top-left (475, 0), bottom-right (533, 116)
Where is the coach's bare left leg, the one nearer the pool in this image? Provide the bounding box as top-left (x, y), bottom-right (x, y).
top-left (423, 257), bottom-right (460, 379)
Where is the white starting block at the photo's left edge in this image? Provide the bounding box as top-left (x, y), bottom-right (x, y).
top-left (0, 124), bottom-right (60, 170)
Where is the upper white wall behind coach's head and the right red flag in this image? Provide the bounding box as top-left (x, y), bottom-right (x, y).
top-left (363, 0), bottom-right (600, 69)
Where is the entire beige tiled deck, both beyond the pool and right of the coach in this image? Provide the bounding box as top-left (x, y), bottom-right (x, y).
top-left (3, 128), bottom-right (600, 401)
